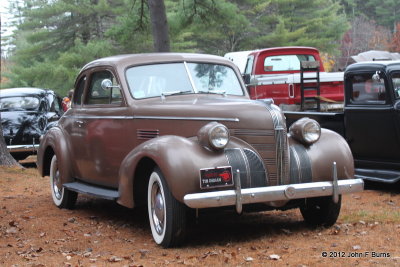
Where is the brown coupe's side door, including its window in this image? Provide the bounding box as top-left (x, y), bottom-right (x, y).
top-left (68, 69), bottom-right (135, 188)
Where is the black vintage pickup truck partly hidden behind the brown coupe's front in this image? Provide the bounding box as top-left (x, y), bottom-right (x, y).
top-left (285, 61), bottom-right (400, 183)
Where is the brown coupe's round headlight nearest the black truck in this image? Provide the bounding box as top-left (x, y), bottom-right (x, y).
top-left (289, 118), bottom-right (321, 145)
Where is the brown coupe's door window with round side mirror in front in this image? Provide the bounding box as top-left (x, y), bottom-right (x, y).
top-left (87, 71), bottom-right (122, 105)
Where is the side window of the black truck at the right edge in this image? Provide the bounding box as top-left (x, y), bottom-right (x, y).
top-left (350, 73), bottom-right (386, 104)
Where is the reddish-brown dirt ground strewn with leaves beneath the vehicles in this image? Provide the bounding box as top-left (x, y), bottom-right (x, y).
top-left (0, 158), bottom-right (400, 267)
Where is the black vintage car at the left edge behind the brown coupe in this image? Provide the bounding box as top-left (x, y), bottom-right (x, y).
top-left (0, 88), bottom-right (63, 160)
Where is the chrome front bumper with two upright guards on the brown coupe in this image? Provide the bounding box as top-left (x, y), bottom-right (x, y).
top-left (183, 163), bottom-right (364, 213)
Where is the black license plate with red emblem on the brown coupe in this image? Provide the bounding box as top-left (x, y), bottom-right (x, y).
top-left (200, 166), bottom-right (233, 189)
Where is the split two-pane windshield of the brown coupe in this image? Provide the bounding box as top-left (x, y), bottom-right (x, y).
top-left (126, 62), bottom-right (244, 99)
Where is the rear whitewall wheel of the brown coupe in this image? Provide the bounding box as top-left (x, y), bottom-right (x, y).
top-left (50, 155), bottom-right (78, 209)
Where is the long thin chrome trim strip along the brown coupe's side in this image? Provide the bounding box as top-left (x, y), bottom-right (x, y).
top-left (64, 115), bottom-right (240, 122)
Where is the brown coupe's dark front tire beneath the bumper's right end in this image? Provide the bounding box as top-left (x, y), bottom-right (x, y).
top-left (300, 196), bottom-right (342, 227)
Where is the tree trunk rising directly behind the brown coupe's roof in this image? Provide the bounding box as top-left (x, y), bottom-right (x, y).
top-left (148, 0), bottom-right (170, 52)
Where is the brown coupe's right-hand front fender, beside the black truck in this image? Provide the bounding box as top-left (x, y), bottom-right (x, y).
top-left (289, 129), bottom-right (354, 183)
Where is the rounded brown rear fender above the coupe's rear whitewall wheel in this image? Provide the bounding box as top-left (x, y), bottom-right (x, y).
top-left (37, 126), bottom-right (73, 183)
